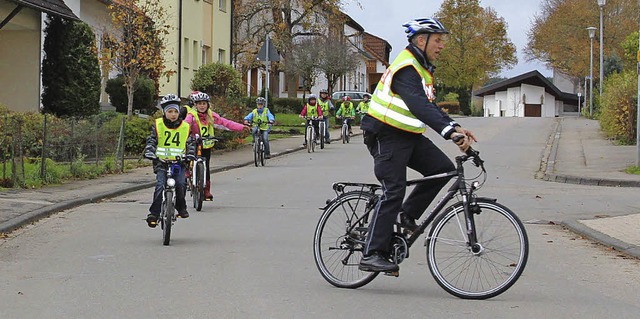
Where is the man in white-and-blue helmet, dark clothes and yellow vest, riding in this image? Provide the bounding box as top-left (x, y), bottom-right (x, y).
top-left (359, 18), bottom-right (476, 272)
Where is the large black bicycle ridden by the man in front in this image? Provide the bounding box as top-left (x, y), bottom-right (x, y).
top-left (313, 148), bottom-right (529, 299)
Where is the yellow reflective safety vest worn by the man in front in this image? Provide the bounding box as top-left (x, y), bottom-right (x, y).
top-left (367, 49), bottom-right (436, 134)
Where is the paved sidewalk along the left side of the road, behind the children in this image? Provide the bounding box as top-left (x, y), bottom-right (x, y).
top-left (0, 129), bottom-right (350, 235)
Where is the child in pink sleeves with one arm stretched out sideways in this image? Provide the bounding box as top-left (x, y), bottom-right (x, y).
top-left (185, 91), bottom-right (249, 201)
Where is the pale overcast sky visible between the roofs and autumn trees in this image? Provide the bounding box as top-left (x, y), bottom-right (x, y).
top-left (343, 0), bottom-right (552, 78)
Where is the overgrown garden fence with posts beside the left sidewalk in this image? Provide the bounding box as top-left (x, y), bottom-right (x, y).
top-left (0, 113), bottom-right (141, 187)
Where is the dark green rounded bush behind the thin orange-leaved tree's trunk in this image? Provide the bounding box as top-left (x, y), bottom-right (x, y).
top-left (105, 75), bottom-right (156, 114)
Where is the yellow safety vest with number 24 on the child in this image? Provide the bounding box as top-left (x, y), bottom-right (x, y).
top-left (156, 118), bottom-right (189, 160)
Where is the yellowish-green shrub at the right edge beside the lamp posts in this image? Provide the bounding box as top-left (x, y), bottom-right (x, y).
top-left (598, 71), bottom-right (638, 145)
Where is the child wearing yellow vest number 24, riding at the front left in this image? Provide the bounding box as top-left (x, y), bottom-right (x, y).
top-left (144, 94), bottom-right (195, 228)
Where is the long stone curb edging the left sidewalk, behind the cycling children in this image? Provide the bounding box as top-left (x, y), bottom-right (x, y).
top-left (0, 133), bottom-right (362, 234)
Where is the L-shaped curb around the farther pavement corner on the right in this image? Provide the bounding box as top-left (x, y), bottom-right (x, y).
top-left (536, 118), bottom-right (640, 187)
